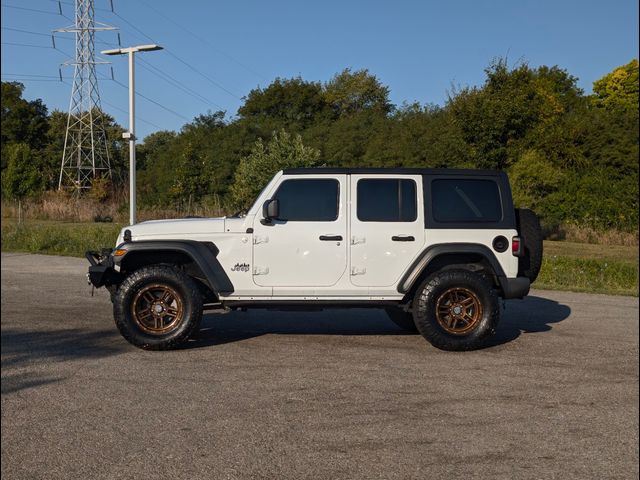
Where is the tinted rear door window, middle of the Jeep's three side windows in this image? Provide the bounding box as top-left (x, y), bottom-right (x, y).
top-left (357, 178), bottom-right (418, 222)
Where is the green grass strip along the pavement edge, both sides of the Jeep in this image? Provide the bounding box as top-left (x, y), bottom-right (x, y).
top-left (1, 218), bottom-right (638, 296)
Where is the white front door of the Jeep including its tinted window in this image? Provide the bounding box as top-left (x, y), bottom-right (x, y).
top-left (253, 175), bottom-right (348, 288)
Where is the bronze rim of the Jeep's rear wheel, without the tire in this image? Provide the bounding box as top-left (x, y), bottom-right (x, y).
top-left (436, 287), bottom-right (482, 335)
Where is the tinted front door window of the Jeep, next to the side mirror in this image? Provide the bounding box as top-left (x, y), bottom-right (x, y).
top-left (273, 178), bottom-right (340, 222)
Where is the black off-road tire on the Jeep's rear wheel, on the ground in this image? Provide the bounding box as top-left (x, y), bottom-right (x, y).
top-left (413, 269), bottom-right (500, 351)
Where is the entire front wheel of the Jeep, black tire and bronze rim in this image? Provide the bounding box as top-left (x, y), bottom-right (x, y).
top-left (113, 265), bottom-right (202, 350)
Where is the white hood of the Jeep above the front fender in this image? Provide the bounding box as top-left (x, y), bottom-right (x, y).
top-left (118, 217), bottom-right (225, 242)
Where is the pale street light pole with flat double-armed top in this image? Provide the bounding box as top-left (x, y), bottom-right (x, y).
top-left (102, 45), bottom-right (162, 225)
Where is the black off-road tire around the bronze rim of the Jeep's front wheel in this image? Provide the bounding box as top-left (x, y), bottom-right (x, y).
top-left (113, 265), bottom-right (202, 350)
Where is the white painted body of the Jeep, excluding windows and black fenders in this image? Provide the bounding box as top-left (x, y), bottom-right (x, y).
top-left (115, 169), bottom-right (518, 302)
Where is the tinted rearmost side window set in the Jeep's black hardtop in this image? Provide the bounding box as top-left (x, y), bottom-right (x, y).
top-left (431, 179), bottom-right (502, 223)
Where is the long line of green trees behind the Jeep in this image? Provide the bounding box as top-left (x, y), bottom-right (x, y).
top-left (2, 59), bottom-right (639, 231)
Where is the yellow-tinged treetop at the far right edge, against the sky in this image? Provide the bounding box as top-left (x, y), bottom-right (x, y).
top-left (593, 59), bottom-right (638, 111)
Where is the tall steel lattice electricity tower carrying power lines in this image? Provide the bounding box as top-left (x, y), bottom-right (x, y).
top-left (56, 0), bottom-right (115, 193)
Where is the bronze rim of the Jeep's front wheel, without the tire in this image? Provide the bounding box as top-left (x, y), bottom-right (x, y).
top-left (131, 283), bottom-right (184, 335)
